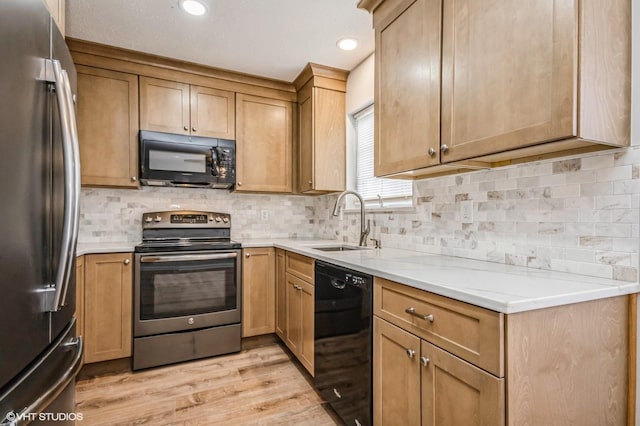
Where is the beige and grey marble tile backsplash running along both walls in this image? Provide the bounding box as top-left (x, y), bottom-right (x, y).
top-left (79, 146), bottom-right (640, 281)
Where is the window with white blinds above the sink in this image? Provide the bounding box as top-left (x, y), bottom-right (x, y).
top-left (353, 105), bottom-right (413, 208)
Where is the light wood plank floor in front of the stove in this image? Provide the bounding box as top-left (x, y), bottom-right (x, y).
top-left (76, 342), bottom-right (340, 426)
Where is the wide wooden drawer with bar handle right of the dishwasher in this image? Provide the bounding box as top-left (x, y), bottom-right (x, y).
top-left (373, 277), bottom-right (504, 377)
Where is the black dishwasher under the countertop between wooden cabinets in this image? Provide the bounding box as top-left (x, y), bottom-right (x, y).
top-left (314, 261), bottom-right (373, 426)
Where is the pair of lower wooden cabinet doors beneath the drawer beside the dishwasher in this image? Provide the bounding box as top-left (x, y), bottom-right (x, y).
top-left (373, 317), bottom-right (504, 426)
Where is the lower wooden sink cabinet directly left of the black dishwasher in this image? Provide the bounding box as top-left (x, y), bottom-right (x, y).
top-left (276, 250), bottom-right (315, 376)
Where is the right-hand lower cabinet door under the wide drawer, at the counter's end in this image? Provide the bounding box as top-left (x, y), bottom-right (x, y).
top-left (420, 340), bottom-right (505, 426)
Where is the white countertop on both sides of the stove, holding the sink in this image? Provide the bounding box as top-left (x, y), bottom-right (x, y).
top-left (77, 239), bottom-right (640, 314)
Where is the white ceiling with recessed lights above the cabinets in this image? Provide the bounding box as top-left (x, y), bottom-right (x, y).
top-left (66, 0), bottom-right (374, 82)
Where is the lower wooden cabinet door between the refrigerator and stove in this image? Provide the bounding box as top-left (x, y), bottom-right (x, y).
top-left (84, 253), bottom-right (133, 363)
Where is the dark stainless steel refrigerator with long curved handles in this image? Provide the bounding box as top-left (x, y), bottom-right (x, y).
top-left (0, 0), bottom-right (82, 425)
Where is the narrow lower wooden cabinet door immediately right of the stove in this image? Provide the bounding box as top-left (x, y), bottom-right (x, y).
top-left (242, 248), bottom-right (275, 337)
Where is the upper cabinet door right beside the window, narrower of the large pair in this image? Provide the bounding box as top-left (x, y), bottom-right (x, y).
top-left (374, 0), bottom-right (441, 176)
